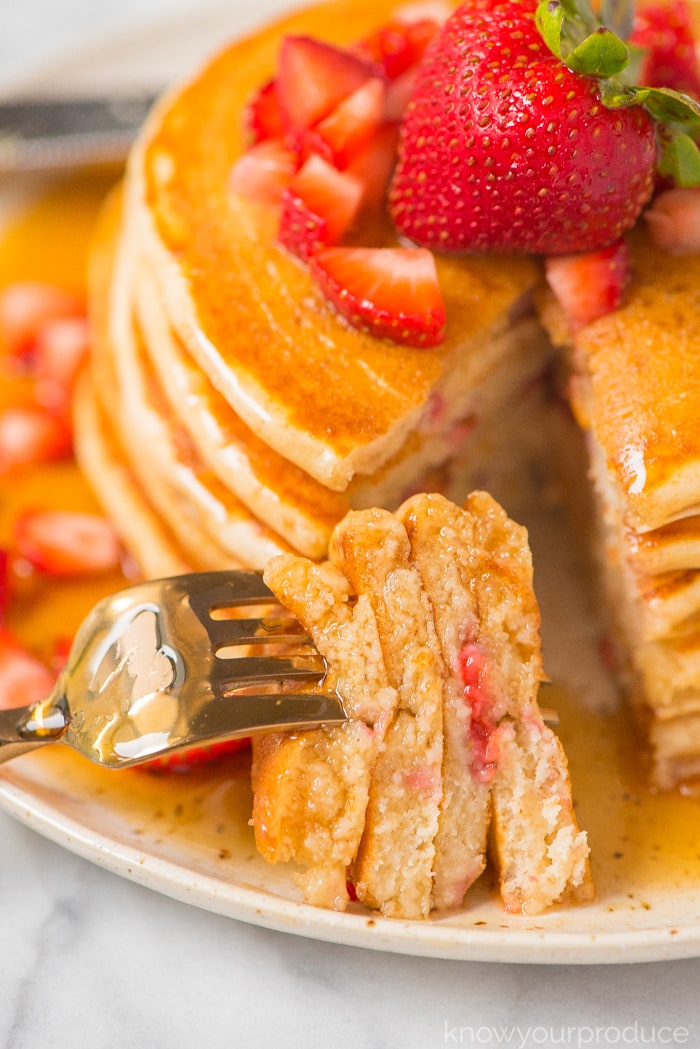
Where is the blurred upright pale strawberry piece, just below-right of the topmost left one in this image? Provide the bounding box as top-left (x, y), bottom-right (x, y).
top-left (34, 317), bottom-right (89, 407)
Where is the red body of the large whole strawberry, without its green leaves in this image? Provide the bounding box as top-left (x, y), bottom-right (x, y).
top-left (389, 0), bottom-right (657, 255)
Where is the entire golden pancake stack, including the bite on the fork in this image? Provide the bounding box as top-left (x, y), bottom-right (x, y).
top-left (77, 0), bottom-right (700, 916)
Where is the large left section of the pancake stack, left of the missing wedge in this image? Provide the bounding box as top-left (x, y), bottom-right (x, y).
top-left (72, 0), bottom-right (549, 574)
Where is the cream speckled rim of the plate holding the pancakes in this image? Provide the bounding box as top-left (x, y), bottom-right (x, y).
top-left (0, 0), bottom-right (700, 965)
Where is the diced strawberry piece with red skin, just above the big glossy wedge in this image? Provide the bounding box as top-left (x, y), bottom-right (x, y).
top-left (278, 155), bottom-right (362, 259)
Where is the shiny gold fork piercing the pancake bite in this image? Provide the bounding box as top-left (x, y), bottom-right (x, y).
top-left (0, 572), bottom-right (347, 768)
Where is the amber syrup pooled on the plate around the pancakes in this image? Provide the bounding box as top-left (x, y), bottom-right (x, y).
top-left (0, 165), bottom-right (700, 922)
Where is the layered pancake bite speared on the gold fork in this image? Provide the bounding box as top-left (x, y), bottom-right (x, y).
top-left (253, 493), bottom-right (591, 918)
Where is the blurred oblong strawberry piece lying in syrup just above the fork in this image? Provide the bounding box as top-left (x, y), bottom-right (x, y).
top-left (14, 510), bottom-right (122, 578)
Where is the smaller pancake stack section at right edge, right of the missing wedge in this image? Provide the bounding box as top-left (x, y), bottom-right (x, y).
top-left (543, 231), bottom-right (700, 788)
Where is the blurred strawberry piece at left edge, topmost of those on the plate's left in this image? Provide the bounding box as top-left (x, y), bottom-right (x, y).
top-left (0, 280), bottom-right (85, 356)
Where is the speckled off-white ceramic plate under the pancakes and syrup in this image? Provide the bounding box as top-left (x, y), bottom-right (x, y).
top-left (0, 0), bottom-right (700, 964)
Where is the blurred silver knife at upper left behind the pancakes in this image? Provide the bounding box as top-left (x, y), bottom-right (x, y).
top-left (0, 92), bottom-right (156, 174)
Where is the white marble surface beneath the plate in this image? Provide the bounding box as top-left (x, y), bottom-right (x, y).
top-left (0, 0), bottom-right (700, 1049)
